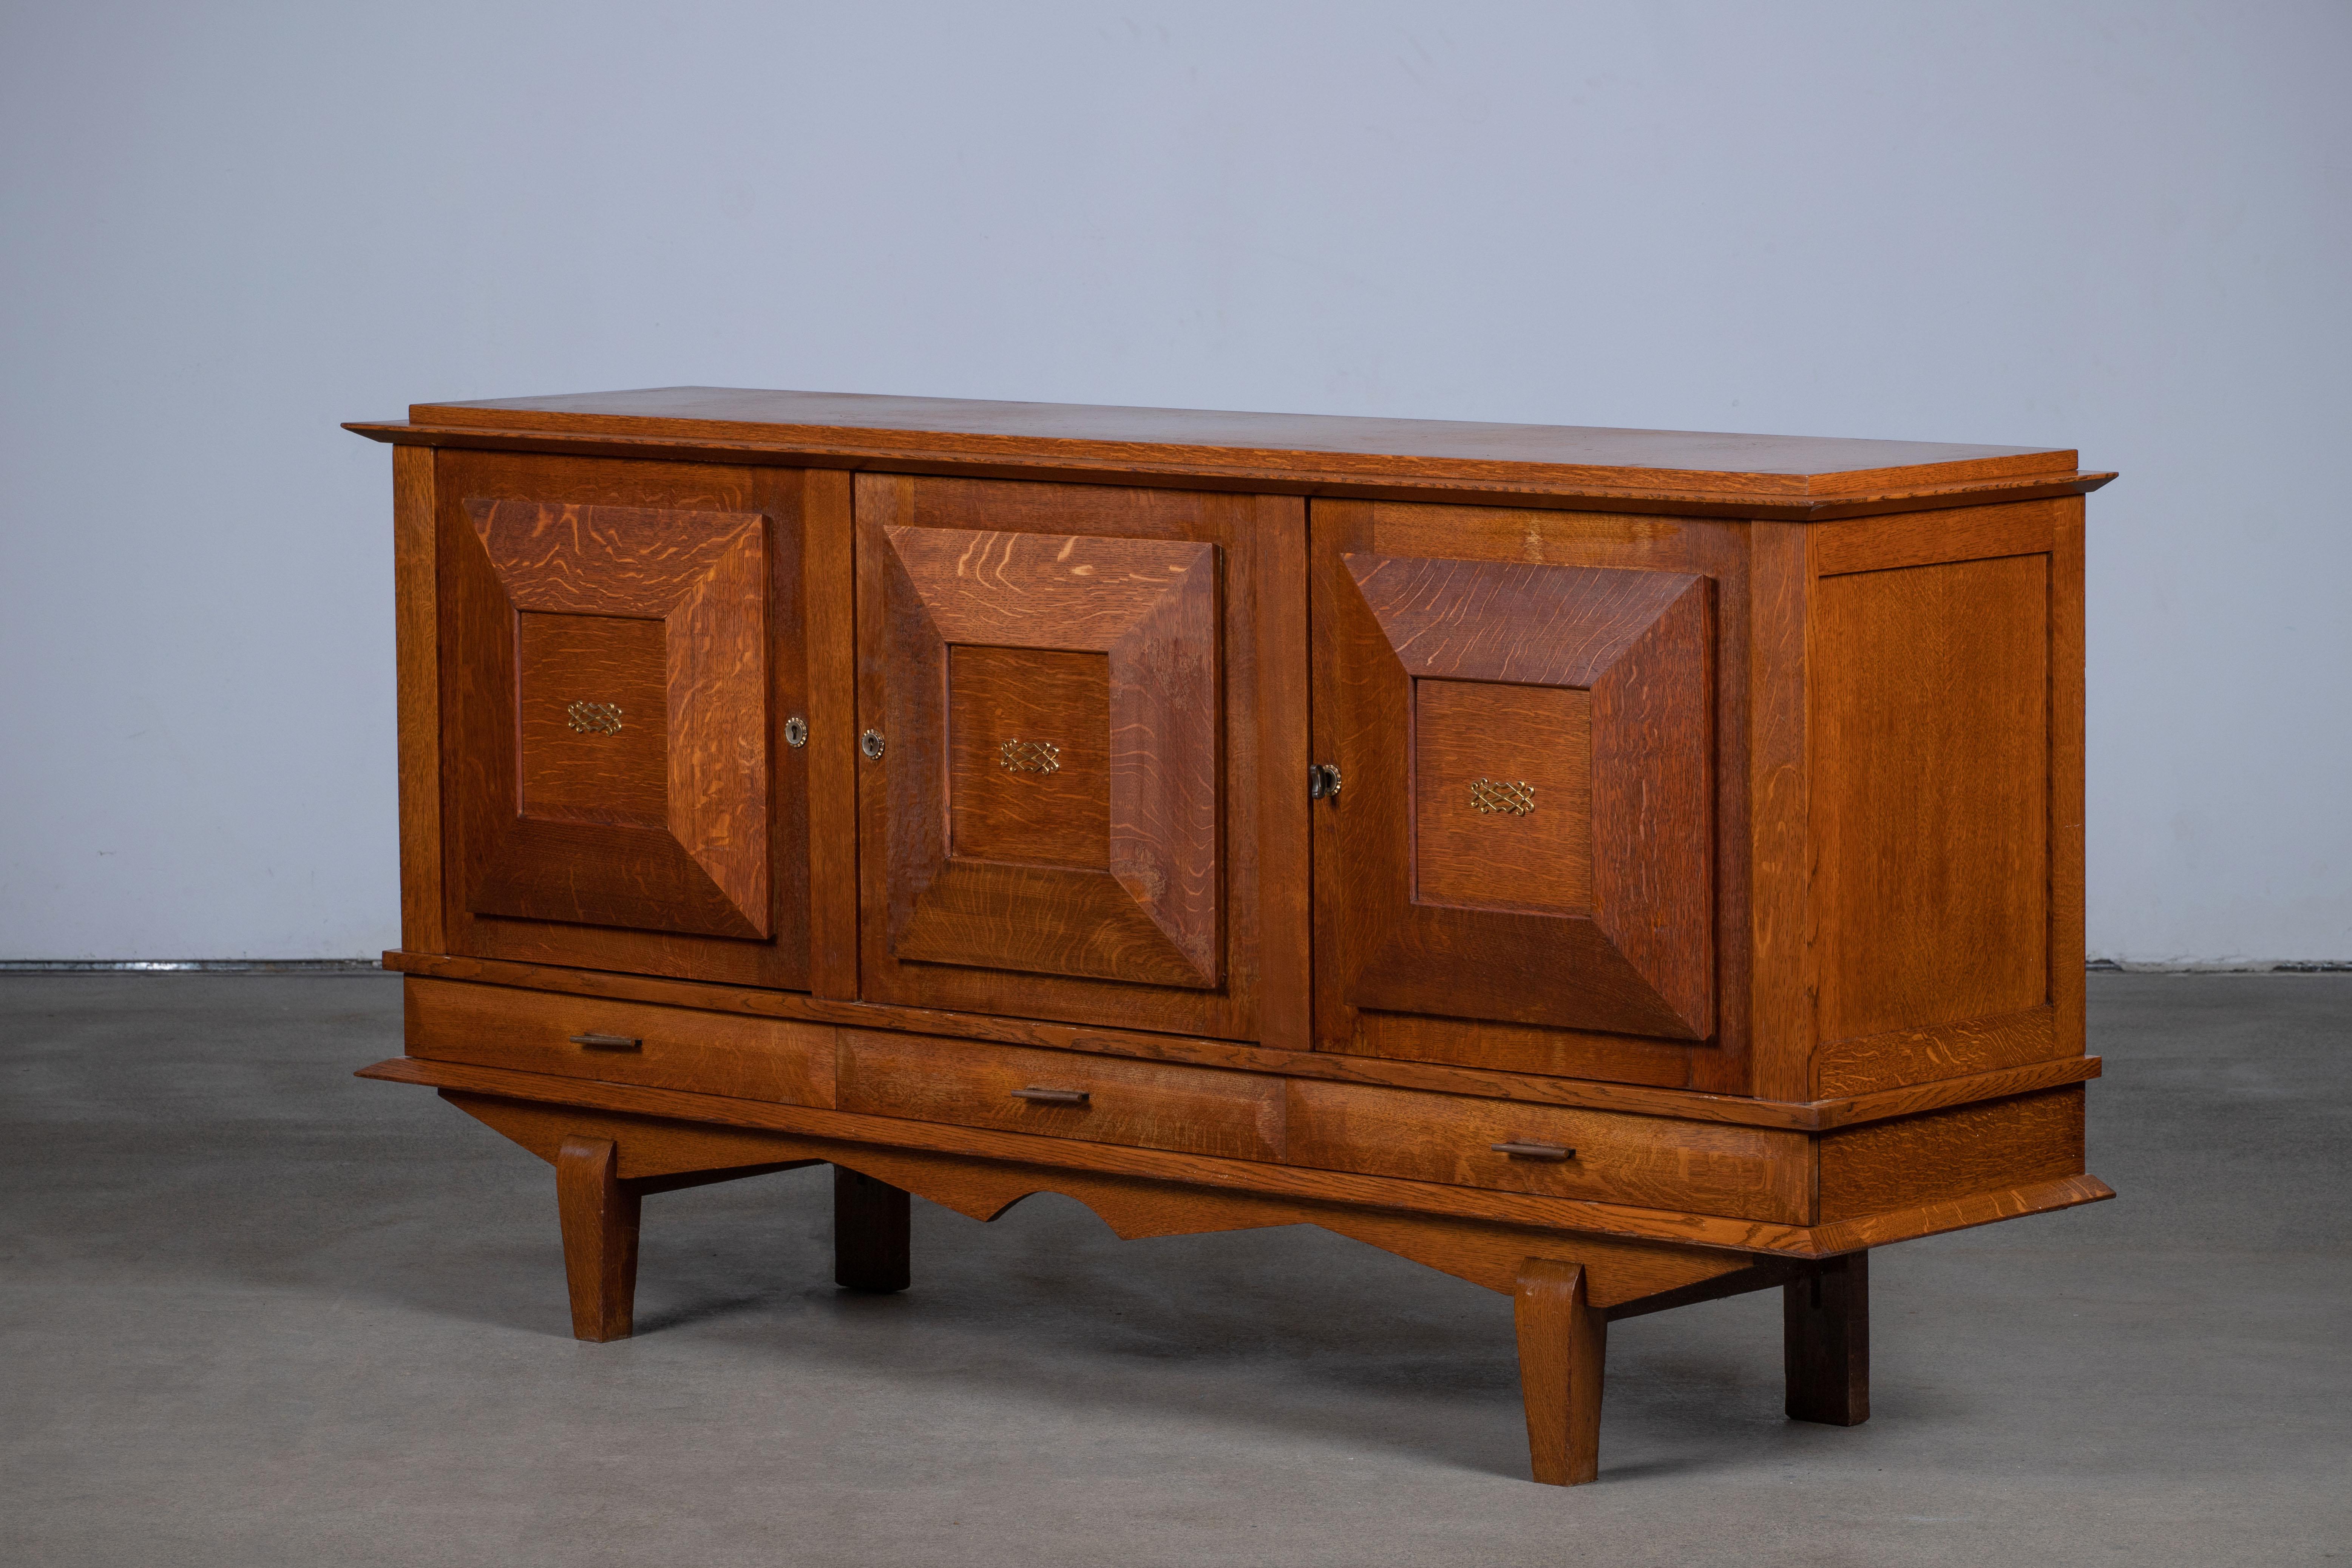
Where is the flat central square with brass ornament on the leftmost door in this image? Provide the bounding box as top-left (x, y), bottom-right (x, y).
top-left (515, 611), bottom-right (670, 828)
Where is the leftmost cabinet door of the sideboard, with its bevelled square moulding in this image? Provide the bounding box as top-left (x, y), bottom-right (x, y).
top-left (435, 451), bottom-right (809, 985)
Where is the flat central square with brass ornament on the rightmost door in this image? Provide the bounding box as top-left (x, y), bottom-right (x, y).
top-left (1413, 680), bottom-right (1592, 915)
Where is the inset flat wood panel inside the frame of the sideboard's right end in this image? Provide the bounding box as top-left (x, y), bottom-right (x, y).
top-left (1813, 555), bottom-right (2051, 1041)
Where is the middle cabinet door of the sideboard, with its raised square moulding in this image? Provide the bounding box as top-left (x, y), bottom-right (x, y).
top-left (856, 475), bottom-right (1308, 1039)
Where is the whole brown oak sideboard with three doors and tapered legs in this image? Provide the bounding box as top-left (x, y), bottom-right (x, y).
top-left (348, 388), bottom-right (2112, 1483)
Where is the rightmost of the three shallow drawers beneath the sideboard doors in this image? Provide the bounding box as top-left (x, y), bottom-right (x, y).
top-left (1289, 1079), bottom-right (1811, 1225)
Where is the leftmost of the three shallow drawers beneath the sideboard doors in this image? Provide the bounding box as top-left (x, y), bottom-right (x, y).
top-left (407, 978), bottom-right (835, 1105)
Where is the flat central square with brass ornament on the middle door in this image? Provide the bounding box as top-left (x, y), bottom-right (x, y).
top-left (948, 646), bottom-right (1110, 872)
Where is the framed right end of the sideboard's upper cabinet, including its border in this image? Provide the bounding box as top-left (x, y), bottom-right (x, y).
top-left (1809, 498), bottom-right (2084, 1095)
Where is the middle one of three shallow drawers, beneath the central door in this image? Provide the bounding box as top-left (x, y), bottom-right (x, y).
top-left (840, 1030), bottom-right (1282, 1159)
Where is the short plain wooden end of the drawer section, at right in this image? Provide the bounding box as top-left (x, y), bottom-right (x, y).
top-left (1821, 1084), bottom-right (2084, 1225)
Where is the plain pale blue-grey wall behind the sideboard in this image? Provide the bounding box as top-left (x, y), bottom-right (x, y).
top-left (0, 0), bottom-right (2352, 959)
